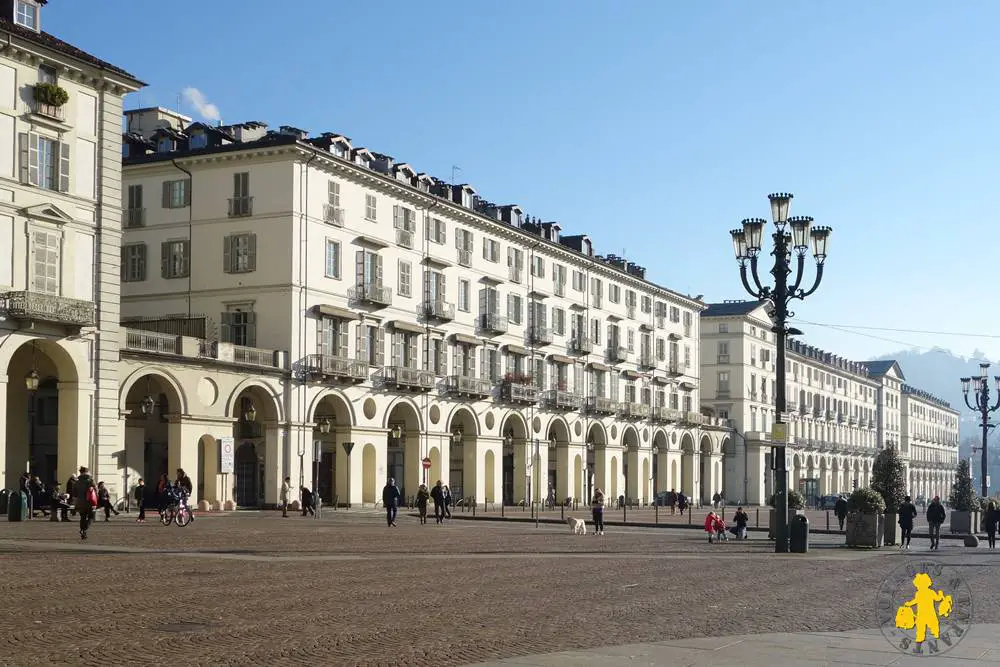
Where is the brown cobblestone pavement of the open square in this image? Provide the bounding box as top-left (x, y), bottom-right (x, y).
top-left (0, 512), bottom-right (1000, 667)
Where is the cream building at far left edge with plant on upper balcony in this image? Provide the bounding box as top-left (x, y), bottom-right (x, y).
top-left (0, 0), bottom-right (143, 488)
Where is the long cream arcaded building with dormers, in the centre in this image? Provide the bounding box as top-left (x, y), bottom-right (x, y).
top-left (121, 108), bottom-right (725, 505)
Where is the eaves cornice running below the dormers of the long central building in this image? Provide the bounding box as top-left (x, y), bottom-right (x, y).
top-left (122, 140), bottom-right (708, 315)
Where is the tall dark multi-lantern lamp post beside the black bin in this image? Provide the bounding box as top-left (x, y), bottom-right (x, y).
top-left (730, 193), bottom-right (832, 553)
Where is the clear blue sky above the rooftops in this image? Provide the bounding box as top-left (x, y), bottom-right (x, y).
top-left (44, 0), bottom-right (1000, 366)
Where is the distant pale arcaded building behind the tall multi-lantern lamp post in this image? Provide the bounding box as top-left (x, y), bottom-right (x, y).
top-left (701, 301), bottom-right (958, 504)
